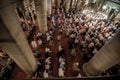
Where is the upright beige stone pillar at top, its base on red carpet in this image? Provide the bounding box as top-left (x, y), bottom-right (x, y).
top-left (34, 0), bottom-right (47, 34)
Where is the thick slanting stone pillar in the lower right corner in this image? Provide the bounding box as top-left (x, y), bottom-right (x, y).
top-left (83, 32), bottom-right (120, 76)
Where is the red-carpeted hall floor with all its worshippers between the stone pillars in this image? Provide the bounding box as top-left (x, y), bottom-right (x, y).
top-left (0, 0), bottom-right (120, 79)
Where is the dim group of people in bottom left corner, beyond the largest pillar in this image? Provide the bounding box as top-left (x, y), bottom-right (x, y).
top-left (0, 49), bottom-right (16, 80)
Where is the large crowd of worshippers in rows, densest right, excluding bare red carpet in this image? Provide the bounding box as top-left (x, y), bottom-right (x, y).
top-left (15, 3), bottom-right (120, 78)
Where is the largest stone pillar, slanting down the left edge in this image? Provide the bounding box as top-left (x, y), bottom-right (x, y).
top-left (0, 0), bottom-right (37, 74)
